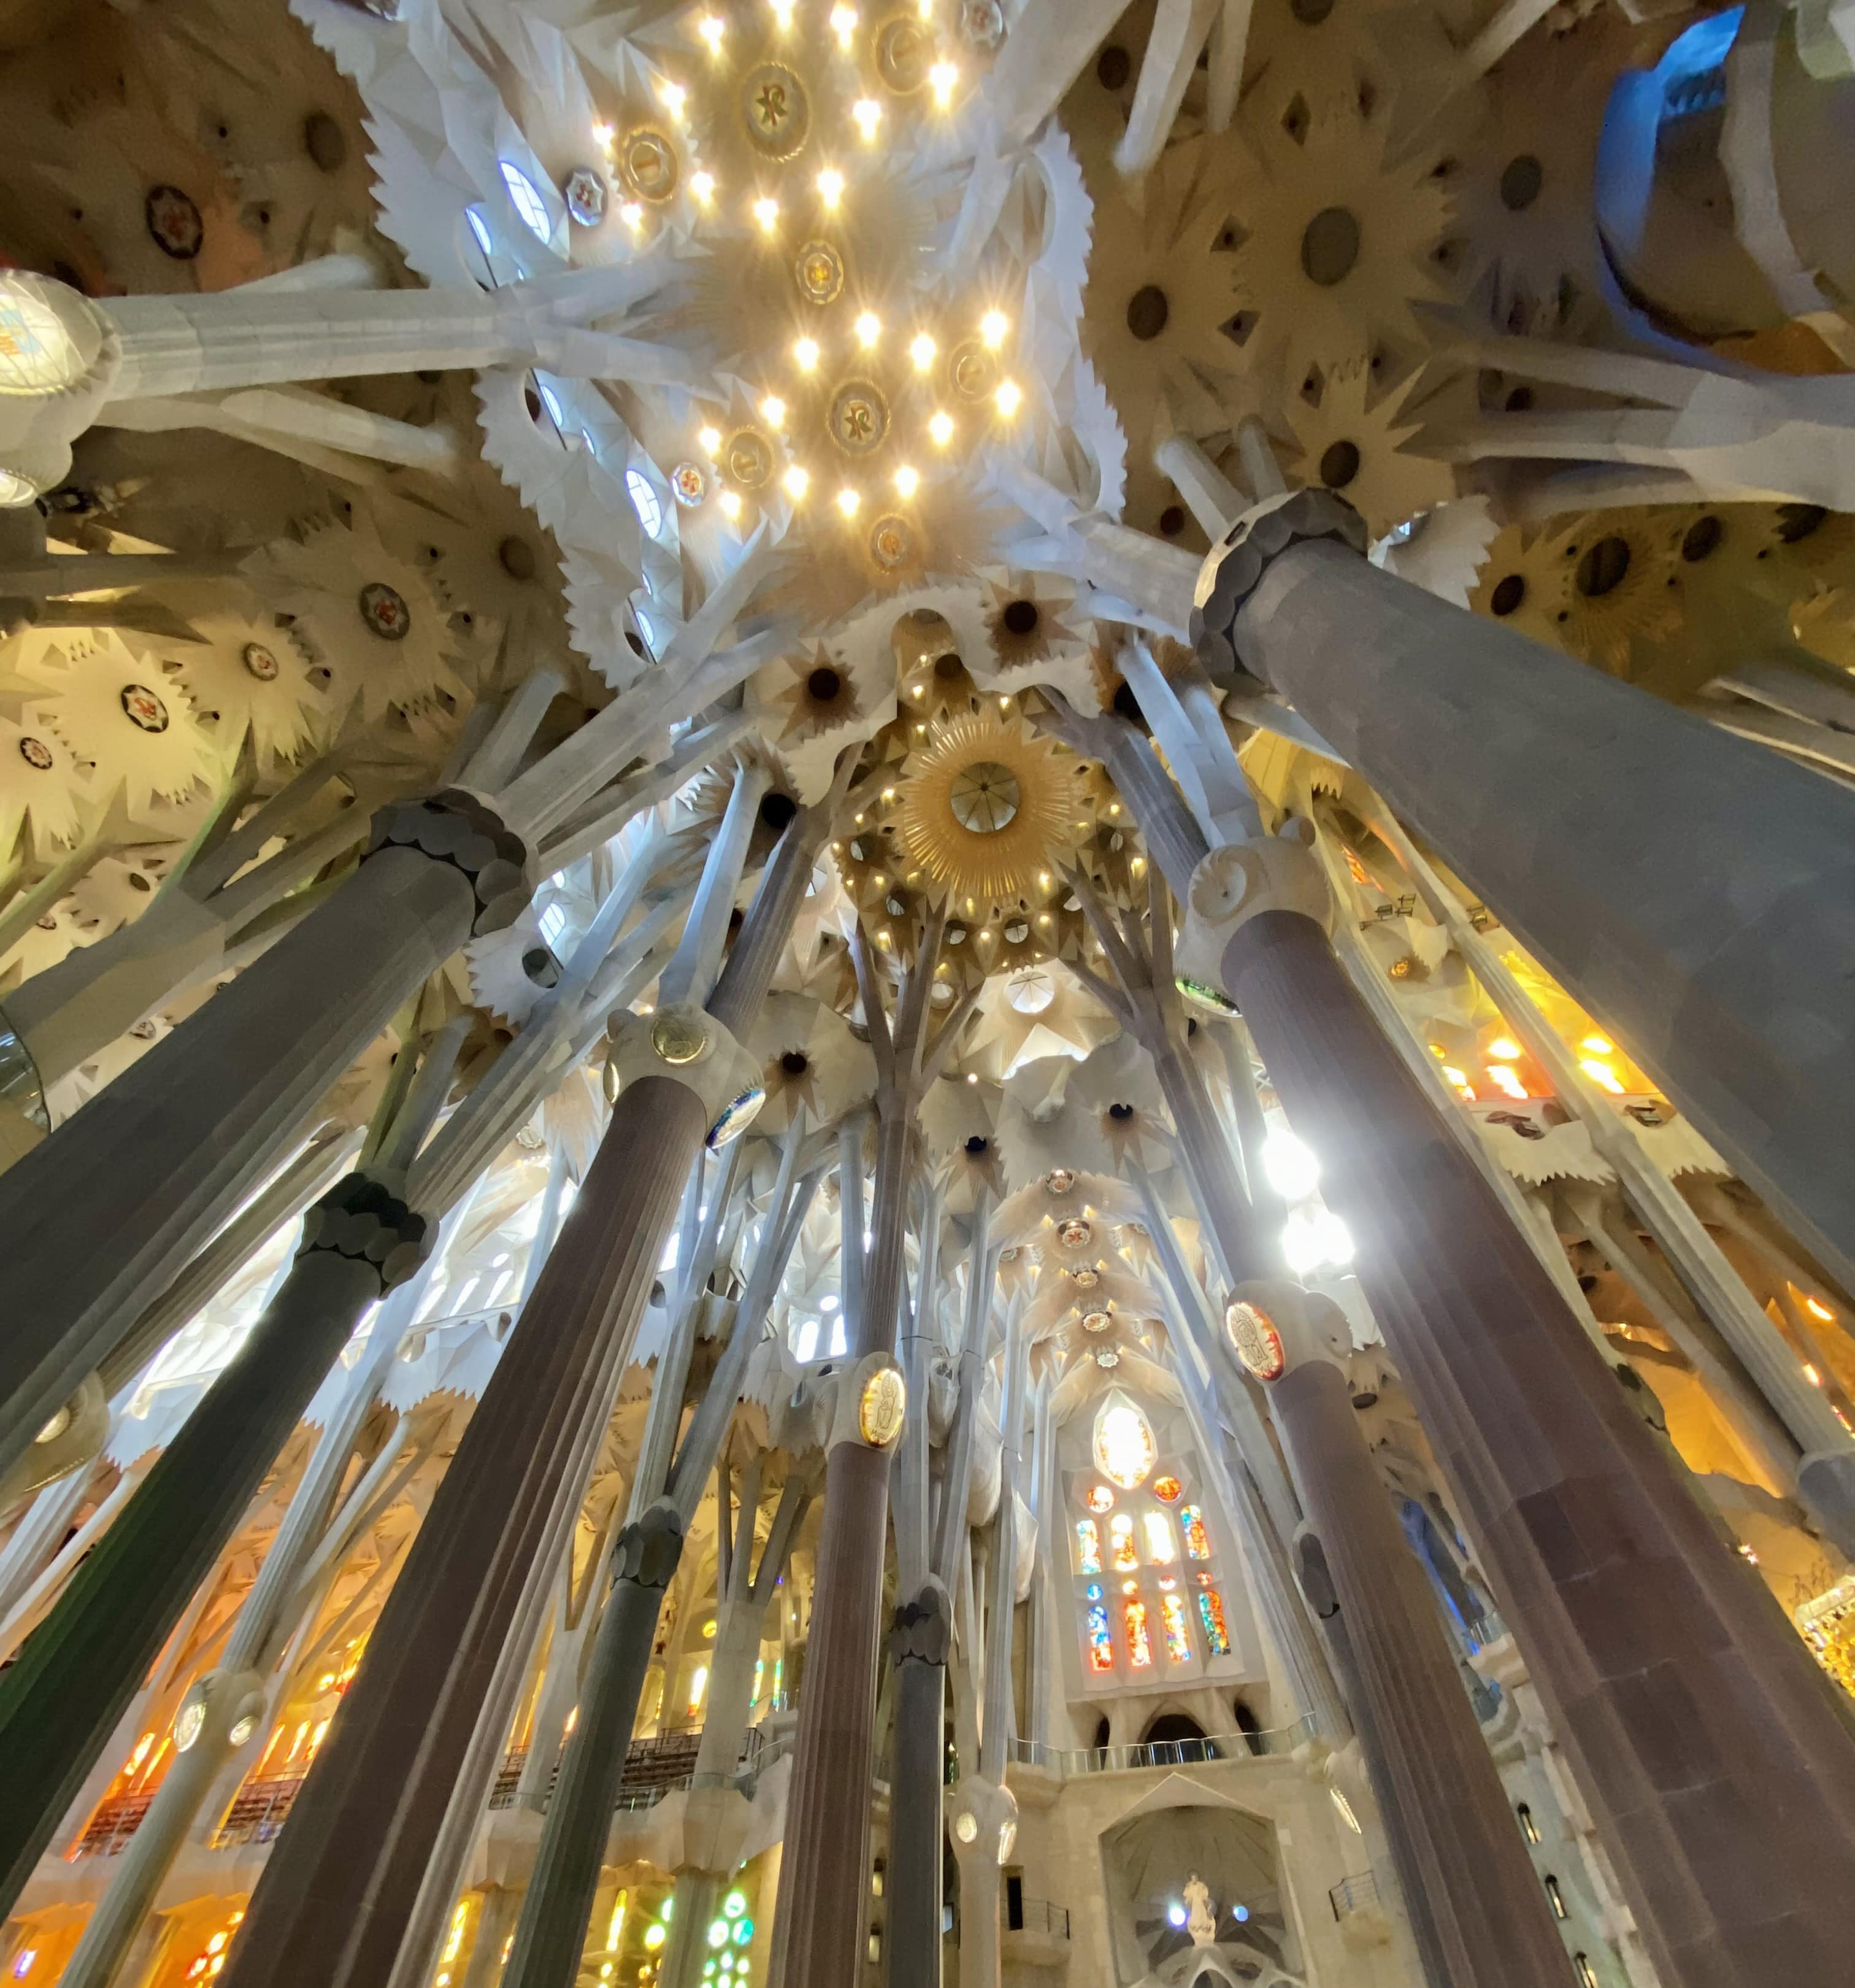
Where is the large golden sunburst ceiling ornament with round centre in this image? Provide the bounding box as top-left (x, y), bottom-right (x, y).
top-left (899, 712), bottom-right (1075, 906)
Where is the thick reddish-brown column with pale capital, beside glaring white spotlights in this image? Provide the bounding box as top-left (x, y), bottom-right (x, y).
top-left (1181, 841), bottom-right (1855, 1988)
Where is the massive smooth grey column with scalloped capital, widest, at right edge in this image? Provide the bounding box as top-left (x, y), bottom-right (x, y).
top-left (1193, 491), bottom-right (1855, 1282)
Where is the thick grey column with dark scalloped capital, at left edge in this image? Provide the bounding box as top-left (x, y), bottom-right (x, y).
top-left (0, 789), bottom-right (529, 1469)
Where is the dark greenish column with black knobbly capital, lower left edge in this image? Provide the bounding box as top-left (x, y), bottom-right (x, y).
top-left (0, 1173), bottom-right (426, 1905)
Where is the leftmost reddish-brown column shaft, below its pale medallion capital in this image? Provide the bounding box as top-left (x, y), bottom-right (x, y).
top-left (223, 1076), bottom-right (706, 1988)
